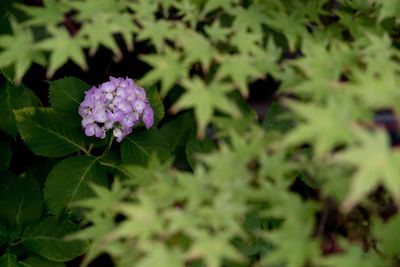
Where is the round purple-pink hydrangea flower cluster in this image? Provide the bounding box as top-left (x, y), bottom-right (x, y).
top-left (79, 77), bottom-right (153, 142)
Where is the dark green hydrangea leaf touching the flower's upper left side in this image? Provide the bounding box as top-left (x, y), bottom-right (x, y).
top-left (49, 77), bottom-right (90, 125)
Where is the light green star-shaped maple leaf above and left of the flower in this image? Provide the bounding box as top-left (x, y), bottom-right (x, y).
top-left (37, 27), bottom-right (87, 77)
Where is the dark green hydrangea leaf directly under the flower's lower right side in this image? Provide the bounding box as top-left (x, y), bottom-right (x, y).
top-left (121, 128), bottom-right (171, 168)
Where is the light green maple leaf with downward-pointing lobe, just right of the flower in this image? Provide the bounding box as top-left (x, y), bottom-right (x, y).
top-left (172, 78), bottom-right (238, 137)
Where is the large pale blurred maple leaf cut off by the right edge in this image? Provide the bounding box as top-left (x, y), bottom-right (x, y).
top-left (333, 129), bottom-right (400, 211)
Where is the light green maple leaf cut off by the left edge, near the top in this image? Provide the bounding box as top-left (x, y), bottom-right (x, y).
top-left (0, 18), bottom-right (46, 82)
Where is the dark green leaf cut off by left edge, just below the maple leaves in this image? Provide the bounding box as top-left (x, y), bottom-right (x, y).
top-left (0, 81), bottom-right (39, 138)
